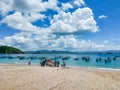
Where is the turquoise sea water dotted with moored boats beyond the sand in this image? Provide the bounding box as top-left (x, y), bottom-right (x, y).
top-left (0, 54), bottom-right (120, 69)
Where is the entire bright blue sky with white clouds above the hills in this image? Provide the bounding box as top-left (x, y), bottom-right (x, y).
top-left (0, 0), bottom-right (120, 51)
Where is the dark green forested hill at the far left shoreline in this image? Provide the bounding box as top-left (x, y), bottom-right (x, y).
top-left (0, 46), bottom-right (24, 54)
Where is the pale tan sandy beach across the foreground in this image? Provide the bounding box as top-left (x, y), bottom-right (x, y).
top-left (0, 65), bottom-right (120, 90)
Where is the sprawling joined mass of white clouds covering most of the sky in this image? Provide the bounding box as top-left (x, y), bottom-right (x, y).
top-left (0, 0), bottom-right (103, 51)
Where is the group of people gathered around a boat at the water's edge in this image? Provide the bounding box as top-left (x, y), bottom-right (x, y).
top-left (28, 59), bottom-right (66, 67)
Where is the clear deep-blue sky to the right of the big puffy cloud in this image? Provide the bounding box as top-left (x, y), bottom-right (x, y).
top-left (85, 0), bottom-right (120, 40)
